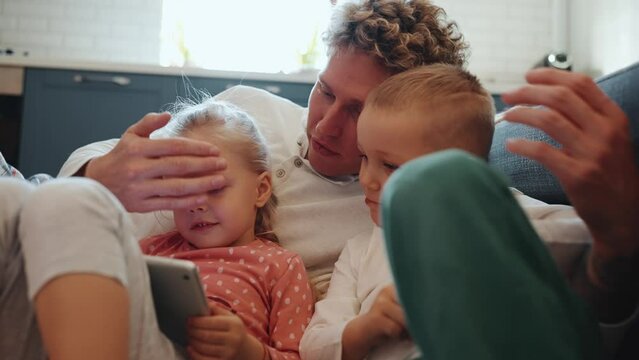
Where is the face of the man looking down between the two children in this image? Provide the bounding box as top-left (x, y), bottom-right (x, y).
top-left (306, 47), bottom-right (390, 176)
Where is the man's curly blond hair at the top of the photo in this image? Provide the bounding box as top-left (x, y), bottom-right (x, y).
top-left (323, 0), bottom-right (468, 73)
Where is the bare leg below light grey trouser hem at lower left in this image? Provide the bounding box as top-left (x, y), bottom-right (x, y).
top-left (35, 274), bottom-right (129, 360)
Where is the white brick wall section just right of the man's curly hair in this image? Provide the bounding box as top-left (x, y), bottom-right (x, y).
top-left (434, 0), bottom-right (563, 91)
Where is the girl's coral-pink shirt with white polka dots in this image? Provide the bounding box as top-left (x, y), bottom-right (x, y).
top-left (140, 231), bottom-right (313, 359)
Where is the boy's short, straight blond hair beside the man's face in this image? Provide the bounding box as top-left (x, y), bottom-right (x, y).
top-left (365, 64), bottom-right (495, 159)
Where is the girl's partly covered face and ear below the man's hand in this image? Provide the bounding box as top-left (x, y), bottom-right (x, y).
top-left (173, 129), bottom-right (271, 248)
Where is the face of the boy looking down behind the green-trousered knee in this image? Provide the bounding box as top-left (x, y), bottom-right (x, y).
top-left (357, 106), bottom-right (436, 226)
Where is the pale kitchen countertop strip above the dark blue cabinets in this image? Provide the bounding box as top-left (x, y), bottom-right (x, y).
top-left (0, 57), bottom-right (317, 84)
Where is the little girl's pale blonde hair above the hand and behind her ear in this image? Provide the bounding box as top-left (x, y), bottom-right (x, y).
top-left (153, 91), bottom-right (278, 242)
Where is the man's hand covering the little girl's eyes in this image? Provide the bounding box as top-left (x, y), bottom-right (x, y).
top-left (84, 113), bottom-right (226, 212)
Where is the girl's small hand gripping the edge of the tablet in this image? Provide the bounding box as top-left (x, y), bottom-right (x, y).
top-left (186, 302), bottom-right (265, 360)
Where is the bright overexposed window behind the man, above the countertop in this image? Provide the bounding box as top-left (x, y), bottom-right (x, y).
top-left (160, 0), bottom-right (331, 73)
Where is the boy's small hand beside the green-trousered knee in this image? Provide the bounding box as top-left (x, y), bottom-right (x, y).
top-left (342, 285), bottom-right (407, 360)
